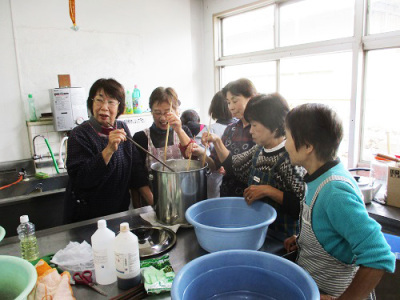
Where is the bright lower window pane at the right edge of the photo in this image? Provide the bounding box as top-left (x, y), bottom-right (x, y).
top-left (361, 48), bottom-right (400, 160)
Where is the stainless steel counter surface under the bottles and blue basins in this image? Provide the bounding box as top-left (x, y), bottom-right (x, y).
top-left (0, 206), bottom-right (285, 300)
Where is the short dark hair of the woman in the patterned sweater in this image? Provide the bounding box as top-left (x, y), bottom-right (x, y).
top-left (244, 93), bottom-right (289, 138)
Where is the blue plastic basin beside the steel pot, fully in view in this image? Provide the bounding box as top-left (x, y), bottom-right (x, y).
top-left (185, 197), bottom-right (276, 252)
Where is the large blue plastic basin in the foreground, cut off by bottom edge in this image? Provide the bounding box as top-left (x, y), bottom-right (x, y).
top-left (171, 250), bottom-right (320, 300)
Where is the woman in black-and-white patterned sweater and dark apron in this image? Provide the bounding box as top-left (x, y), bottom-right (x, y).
top-left (212, 94), bottom-right (304, 241)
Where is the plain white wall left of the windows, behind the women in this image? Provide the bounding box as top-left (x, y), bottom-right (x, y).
top-left (0, 0), bottom-right (203, 162)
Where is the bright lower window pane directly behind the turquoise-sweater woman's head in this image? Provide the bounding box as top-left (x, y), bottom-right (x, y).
top-left (280, 52), bottom-right (351, 162)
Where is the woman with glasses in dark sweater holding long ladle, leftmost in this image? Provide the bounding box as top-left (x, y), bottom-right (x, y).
top-left (65, 79), bottom-right (153, 223)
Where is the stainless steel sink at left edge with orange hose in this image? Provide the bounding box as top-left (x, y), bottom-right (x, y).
top-left (0, 174), bottom-right (68, 203)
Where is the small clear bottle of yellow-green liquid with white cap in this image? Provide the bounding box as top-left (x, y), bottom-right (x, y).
top-left (17, 215), bottom-right (39, 261)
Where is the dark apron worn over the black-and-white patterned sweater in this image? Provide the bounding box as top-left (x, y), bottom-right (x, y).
top-left (247, 146), bottom-right (299, 241)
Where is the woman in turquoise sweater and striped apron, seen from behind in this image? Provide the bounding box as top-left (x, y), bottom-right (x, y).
top-left (284, 103), bottom-right (395, 299)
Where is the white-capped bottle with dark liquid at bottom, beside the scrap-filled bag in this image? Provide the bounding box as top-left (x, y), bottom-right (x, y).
top-left (114, 222), bottom-right (140, 290)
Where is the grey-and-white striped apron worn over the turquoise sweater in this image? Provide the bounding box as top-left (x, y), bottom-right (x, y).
top-left (296, 175), bottom-right (375, 299)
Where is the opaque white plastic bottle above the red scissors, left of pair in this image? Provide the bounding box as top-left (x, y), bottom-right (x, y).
top-left (91, 220), bottom-right (117, 285)
